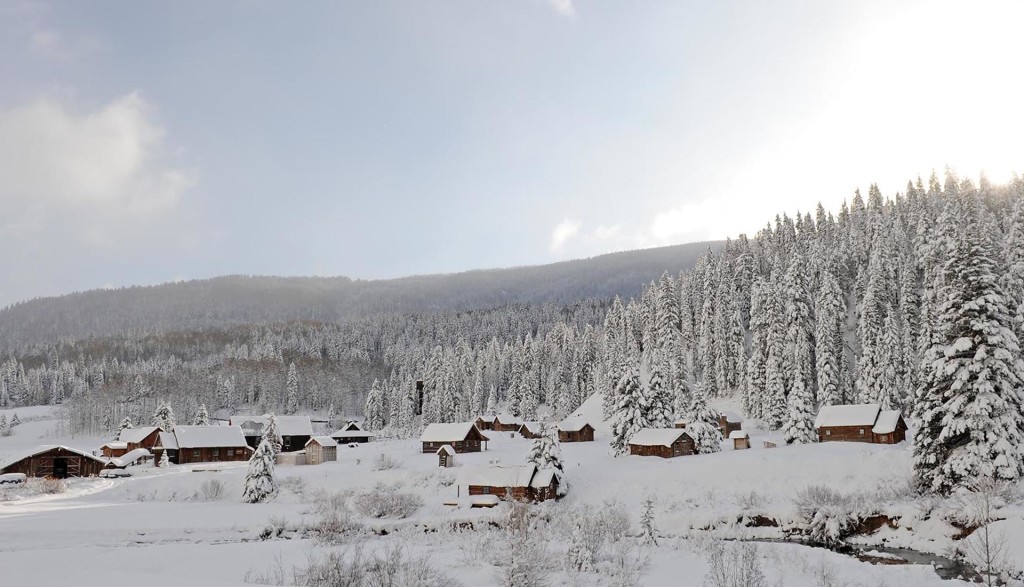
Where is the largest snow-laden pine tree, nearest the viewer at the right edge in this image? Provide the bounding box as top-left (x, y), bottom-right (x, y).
top-left (914, 195), bottom-right (1024, 495)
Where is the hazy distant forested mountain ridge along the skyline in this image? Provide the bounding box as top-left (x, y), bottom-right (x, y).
top-left (0, 242), bottom-right (722, 349)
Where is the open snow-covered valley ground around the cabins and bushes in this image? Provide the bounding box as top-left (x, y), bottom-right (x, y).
top-left (0, 400), bottom-right (1024, 587)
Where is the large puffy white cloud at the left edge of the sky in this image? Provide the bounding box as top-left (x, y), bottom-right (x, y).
top-left (0, 93), bottom-right (193, 245)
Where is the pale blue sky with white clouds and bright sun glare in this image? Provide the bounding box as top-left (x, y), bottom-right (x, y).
top-left (0, 0), bottom-right (1024, 305)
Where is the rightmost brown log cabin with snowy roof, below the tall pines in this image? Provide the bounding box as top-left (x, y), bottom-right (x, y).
top-left (814, 404), bottom-right (907, 445)
